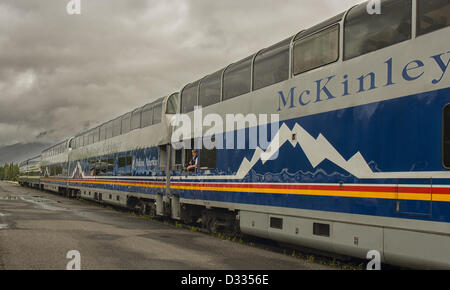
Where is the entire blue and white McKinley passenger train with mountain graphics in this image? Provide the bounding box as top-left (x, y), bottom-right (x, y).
top-left (19, 0), bottom-right (450, 269)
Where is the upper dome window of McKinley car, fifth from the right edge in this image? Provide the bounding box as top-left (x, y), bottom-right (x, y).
top-left (223, 56), bottom-right (253, 100)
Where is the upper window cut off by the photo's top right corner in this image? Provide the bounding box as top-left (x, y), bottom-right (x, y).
top-left (417, 0), bottom-right (450, 35)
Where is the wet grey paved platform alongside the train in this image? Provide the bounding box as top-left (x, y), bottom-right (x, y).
top-left (0, 182), bottom-right (330, 270)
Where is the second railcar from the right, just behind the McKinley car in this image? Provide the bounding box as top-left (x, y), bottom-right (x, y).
top-left (68, 94), bottom-right (178, 215)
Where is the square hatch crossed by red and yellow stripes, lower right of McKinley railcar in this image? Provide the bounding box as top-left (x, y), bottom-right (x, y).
top-left (396, 178), bottom-right (433, 217)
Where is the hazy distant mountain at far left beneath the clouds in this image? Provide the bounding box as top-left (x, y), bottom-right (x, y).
top-left (0, 143), bottom-right (51, 166)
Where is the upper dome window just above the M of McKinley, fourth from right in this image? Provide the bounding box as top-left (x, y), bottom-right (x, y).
top-left (253, 38), bottom-right (291, 90)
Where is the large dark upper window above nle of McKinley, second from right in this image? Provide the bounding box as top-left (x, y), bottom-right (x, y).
top-left (344, 0), bottom-right (412, 60)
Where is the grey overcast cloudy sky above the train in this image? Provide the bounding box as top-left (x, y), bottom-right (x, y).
top-left (0, 0), bottom-right (362, 145)
